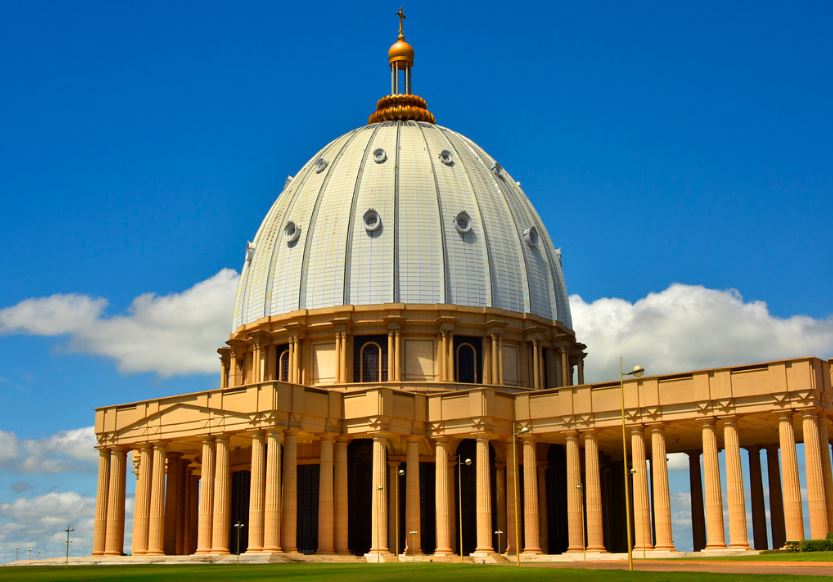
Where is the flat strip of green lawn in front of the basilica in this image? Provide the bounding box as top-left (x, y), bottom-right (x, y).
top-left (0, 564), bottom-right (829, 582)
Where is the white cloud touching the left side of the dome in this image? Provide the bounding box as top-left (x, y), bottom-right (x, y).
top-left (0, 269), bottom-right (238, 376)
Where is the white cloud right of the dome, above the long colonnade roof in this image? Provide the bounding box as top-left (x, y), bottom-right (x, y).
top-left (570, 284), bottom-right (833, 381)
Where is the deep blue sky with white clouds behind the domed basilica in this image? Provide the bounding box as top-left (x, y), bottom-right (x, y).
top-left (0, 1), bottom-right (833, 558)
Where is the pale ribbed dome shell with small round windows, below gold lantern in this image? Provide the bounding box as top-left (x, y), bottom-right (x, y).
top-left (234, 121), bottom-right (572, 329)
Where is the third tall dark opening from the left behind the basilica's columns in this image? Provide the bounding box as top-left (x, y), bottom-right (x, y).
top-left (347, 439), bottom-right (373, 556)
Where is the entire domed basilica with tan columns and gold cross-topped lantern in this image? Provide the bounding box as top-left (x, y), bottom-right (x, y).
top-left (93, 12), bottom-right (833, 561)
